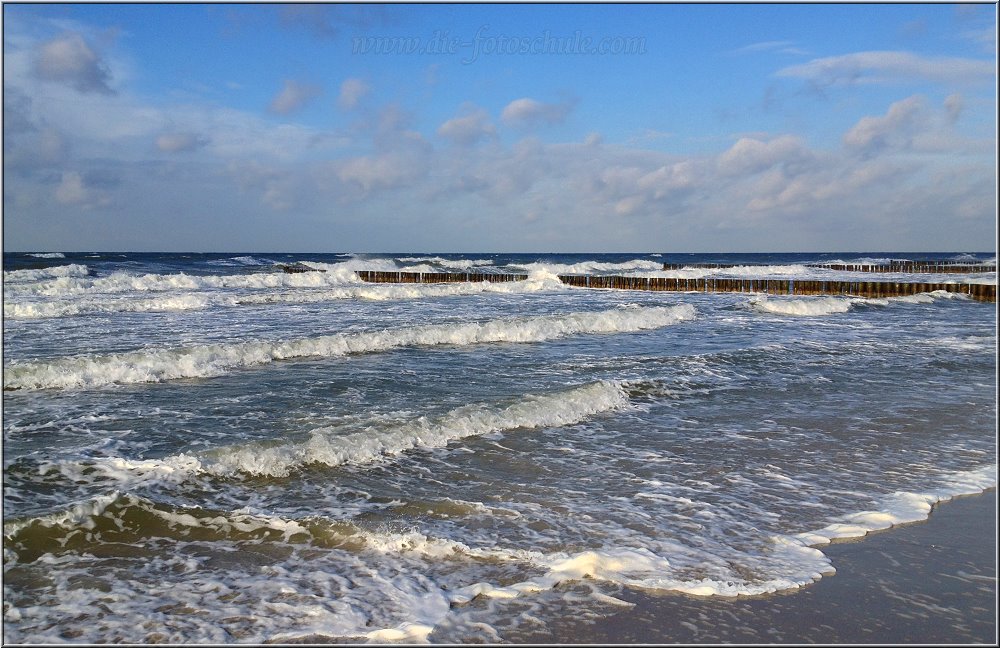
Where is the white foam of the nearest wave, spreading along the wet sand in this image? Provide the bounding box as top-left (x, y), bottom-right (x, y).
top-left (5, 465), bottom-right (996, 642)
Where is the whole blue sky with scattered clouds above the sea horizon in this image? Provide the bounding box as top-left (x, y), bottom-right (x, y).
top-left (3, 4), bottom-right (997, 252)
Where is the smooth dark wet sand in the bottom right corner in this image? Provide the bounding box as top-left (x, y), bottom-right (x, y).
top-left (507, 489), bottom-right (997, 645)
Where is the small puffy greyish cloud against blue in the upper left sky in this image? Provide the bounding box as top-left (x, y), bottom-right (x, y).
top-left (34, 32), bottom-right (114, 94)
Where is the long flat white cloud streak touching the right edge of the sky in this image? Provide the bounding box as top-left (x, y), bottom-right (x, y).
top-left (777, 51), bottom-right (996, 85)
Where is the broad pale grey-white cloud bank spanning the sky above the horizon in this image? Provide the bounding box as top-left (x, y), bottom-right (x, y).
top-left (4, 12), bottom-right (996, 251)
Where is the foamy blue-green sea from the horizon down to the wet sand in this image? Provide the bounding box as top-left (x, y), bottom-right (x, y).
top-left (3, 253), bottom-right (997, 643)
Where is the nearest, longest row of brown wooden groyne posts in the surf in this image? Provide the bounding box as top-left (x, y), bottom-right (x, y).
top-left (358, 270), bottom-right (997, 302)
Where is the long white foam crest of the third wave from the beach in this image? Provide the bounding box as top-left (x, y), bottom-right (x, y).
top-left (4, 304), bottom-right (695, 389)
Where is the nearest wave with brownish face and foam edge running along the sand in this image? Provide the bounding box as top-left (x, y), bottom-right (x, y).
top-left (15, 464), bottom-right (996, 605)
